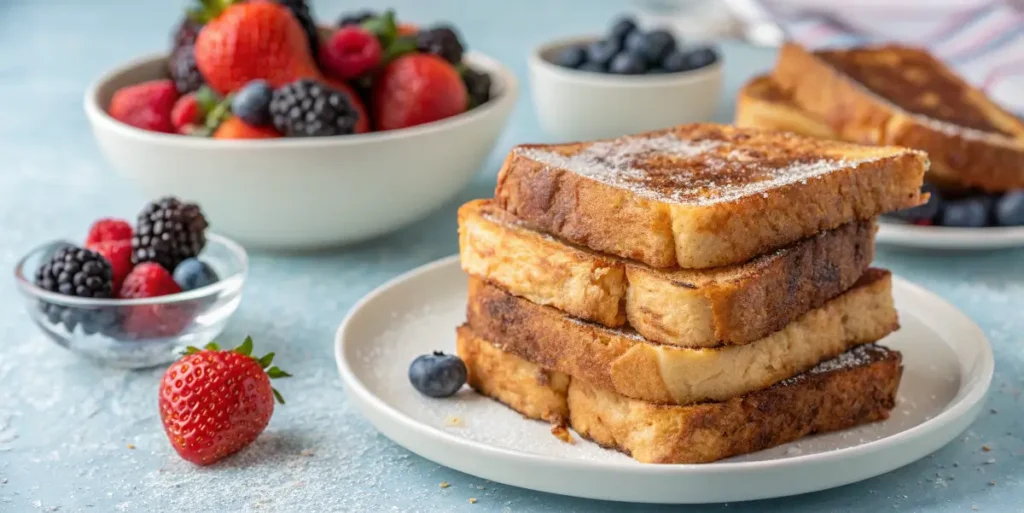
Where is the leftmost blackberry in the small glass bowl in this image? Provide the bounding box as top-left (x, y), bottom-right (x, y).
top-left (34, 245), bottom-right (118, 335)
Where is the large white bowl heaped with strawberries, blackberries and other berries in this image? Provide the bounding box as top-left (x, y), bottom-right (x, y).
top-left (85, 0), bottom-right (517, 249)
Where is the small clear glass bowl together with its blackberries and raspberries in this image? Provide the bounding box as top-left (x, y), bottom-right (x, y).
top-left (14, 198), bottom-right (249, 369)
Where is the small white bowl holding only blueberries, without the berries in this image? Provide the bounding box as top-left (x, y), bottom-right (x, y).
top-left (529, 37), bottom-right (722, 140)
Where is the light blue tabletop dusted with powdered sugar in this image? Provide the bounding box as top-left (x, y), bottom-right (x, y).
top-left (0, 0), bottom-right (1024, 512)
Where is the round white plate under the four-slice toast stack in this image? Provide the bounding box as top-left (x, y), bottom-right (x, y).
top-left (335, 256), bottom-right (993, 504)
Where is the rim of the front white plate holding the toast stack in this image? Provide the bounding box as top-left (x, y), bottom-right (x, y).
top-left (334, 254), bottom-right (994, 504)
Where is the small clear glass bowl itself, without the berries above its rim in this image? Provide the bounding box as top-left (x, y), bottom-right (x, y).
top-left (14, 233), bottom-right (249, 369)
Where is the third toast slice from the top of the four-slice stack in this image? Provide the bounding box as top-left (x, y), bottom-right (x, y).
top-left (466, 268), bottom-right (899, 404)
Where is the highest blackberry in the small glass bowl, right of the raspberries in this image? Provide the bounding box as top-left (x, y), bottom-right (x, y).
top-left (131, 197), bottom-right (209, 272)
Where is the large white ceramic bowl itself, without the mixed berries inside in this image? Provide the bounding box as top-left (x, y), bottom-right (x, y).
top-left (85, 53), bottom-right (518, 249)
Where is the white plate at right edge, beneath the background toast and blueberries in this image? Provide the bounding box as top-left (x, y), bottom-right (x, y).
top-left (876, 220), bottom-right (1024, 250)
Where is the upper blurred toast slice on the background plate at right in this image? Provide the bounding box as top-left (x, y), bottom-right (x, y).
top-left (772, 43), bottom-right (1024, 193)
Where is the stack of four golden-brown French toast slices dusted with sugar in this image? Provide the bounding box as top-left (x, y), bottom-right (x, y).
top-left (458, 124), bottom-right (929, 463)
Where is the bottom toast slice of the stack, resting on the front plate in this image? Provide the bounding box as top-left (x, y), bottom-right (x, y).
top-left (458, 326), bottom-right (902, 463)
